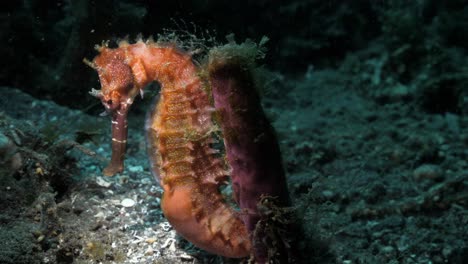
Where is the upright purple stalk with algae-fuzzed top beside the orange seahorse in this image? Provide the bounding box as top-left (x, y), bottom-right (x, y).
top-left (208, 42), bottom-right (290, 263)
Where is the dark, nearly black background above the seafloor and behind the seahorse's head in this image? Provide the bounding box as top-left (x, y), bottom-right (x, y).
top-left (0, 0), bottom-right (468, 112)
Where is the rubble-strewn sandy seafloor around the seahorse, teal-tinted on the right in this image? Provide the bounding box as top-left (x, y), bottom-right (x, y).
top-left (0, 64), bottom-right (468, 264)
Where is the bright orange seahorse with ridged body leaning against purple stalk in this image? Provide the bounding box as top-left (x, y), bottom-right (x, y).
top-left (93, 41), bottom-right (251, 258)
